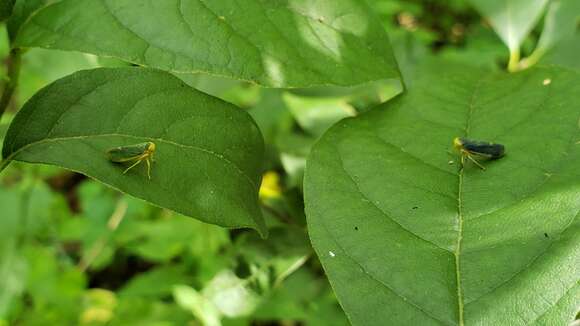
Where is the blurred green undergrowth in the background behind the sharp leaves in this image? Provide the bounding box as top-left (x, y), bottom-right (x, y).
top-left (0, 0), bottom-right (580, 326)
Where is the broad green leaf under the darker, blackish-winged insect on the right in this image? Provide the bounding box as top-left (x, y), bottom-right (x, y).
top-left (305, 63), bottom-right (580, 325)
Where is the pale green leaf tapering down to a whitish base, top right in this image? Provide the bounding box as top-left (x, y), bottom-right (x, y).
top-left (469, 0), bottom-right (548, 64)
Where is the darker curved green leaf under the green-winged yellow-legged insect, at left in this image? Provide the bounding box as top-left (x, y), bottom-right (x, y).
top-left (3, 68), bottom-right (267, 235)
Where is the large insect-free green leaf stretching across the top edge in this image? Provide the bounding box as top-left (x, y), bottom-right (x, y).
top-left (16, 0), bottom-right (399, 87)
